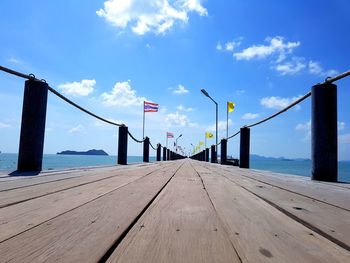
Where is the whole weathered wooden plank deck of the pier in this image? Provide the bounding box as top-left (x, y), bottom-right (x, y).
top-left (0, 160), bottom-right (350, 263)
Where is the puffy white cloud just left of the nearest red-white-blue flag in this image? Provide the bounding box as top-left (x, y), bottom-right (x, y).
top-left (101, 81), bottom-right (147, 107)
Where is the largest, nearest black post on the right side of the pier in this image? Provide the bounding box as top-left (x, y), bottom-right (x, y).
top-left (311, 83), bottom-right (338, 182)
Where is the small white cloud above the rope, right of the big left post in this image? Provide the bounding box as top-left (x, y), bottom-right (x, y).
top-left (58, 79), bottom-right (96, 96)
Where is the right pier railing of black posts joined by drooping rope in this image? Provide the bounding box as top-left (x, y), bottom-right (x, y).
top-left (191, 71), bottom-right (350, 182)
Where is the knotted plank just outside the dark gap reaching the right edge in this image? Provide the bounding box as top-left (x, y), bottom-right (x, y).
top-left (202, 166), bottom-right (350, 253)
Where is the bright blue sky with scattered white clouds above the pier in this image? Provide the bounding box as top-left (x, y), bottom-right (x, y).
top-left (0, 0), bottom-right (350, 160)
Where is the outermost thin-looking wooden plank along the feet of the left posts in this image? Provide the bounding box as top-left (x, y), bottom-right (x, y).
top-left (0, 163), bottom-right (154, 192)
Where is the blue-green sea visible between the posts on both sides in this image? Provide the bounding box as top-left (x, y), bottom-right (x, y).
top-left (0, 153), bottom-right (350, 183)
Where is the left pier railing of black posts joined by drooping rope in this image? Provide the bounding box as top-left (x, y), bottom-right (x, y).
top-left (0, 66), bottom-right (185, 172)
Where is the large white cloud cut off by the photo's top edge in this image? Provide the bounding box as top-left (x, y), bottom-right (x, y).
top-left (96, 0), bottom-right (208, 35)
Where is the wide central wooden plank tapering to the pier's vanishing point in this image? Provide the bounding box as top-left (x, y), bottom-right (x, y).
top-left (107, 161), bottom-right (240, 262)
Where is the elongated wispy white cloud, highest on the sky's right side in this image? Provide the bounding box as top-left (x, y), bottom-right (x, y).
top-left (233, 36), bottom-right (300, 63)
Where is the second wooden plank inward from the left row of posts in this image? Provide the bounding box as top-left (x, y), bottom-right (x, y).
top-left (0, 163), bottom-right (168, 208)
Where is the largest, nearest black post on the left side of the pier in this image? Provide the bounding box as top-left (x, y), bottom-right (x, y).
top-left (17, 80), bottom-right (48, 171)
